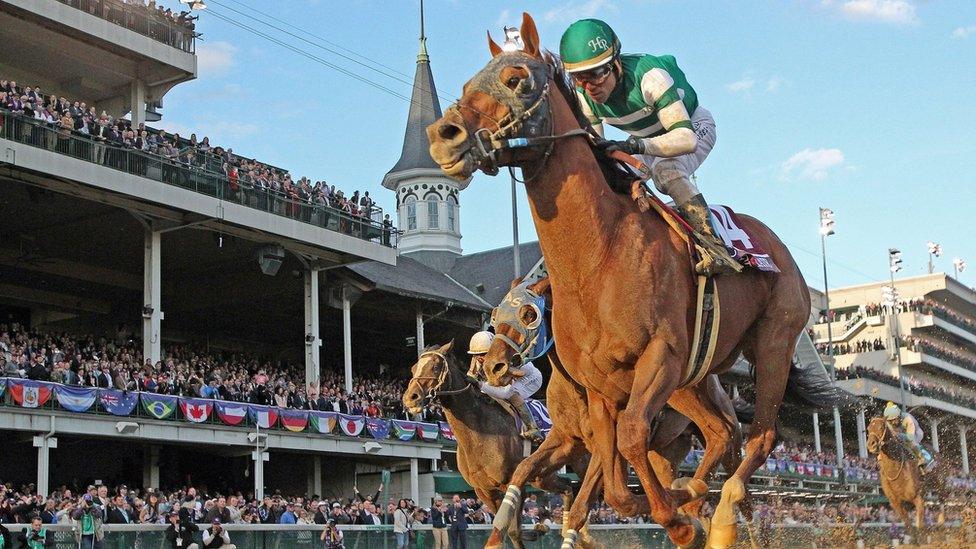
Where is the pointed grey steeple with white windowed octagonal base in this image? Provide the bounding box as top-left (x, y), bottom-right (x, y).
top-left (383, 0), bottom-right (471, 271)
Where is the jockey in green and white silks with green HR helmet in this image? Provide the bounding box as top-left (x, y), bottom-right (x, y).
top-left (559, 19), bottom-right (741, 275)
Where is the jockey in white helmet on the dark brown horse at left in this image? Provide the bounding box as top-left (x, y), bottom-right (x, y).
top-left (468, 332), bottom-right (542, 443)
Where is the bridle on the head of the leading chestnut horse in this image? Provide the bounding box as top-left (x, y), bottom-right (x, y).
top-left (448, 57), bottom-right (592, 183)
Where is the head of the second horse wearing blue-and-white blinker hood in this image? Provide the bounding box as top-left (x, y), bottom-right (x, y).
top-left (484, 278), bottom-right (552, 387)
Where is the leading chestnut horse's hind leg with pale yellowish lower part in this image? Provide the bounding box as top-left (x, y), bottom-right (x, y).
top-left (708, 324), bottom-right (802, 549)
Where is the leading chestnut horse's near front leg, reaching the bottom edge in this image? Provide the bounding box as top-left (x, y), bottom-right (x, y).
top-left (617, 338), bottom-right (704, 547)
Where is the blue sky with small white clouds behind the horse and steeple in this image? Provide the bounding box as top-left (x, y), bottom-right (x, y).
top-left (159, 0), bottom-right (976, 287)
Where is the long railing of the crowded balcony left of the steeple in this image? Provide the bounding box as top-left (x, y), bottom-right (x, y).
top-left (0, 109), bottom-right (398, 247)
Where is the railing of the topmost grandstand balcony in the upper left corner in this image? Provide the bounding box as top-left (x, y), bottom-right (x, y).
top-left (58, 0), bottom-right (198, 53)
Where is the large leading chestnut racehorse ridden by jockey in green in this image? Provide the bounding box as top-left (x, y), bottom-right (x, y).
top-left (427, 14), bottom-right (829, 547)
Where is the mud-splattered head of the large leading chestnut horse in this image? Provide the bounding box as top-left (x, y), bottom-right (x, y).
top-left (427, 13), bottom-right (554, 179)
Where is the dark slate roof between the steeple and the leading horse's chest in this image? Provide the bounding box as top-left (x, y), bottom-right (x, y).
top-left (449, 241), bottom-right (542, 307)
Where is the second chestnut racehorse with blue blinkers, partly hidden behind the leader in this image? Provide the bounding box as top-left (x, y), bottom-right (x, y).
top-left (485, 277), bottom-right (742, 531)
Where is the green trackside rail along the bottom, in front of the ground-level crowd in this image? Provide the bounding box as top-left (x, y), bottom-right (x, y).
top-left (0, 522), bottom-right (964, 549)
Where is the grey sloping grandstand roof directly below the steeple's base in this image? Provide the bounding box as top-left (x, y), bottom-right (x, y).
top-left (348, 255), bottom-right (492, 311)
